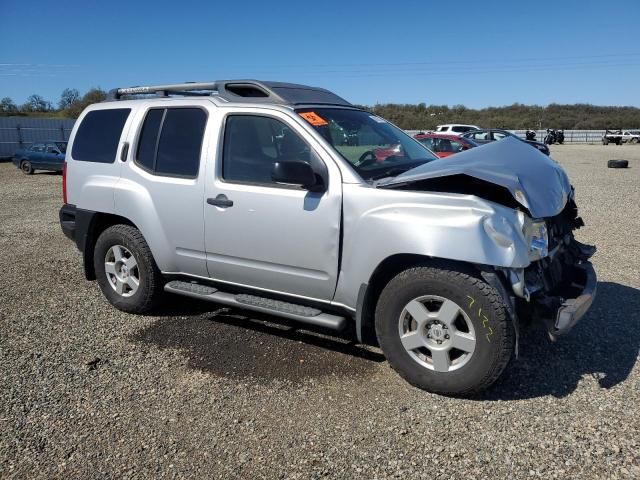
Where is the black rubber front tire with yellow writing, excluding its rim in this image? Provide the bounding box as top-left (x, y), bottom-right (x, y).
top-left (375, 264), bottom-right (515, 396)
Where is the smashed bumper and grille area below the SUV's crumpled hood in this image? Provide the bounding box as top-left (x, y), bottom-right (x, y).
top-left (504, 199), bottom-right (597, 338)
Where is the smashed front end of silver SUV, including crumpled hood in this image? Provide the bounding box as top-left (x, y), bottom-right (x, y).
top-left (376, 139), bottom-right (597, 337)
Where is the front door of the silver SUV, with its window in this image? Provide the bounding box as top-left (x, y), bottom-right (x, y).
top-left (205, 109), bottom-right (342, 300)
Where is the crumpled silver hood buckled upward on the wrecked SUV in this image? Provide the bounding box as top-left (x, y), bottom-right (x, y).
top-left (377, 138), bottom-right (571, 218)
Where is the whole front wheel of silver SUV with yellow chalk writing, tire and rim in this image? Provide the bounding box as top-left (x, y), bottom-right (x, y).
top-left (375, 264), bottom-right (515, 396)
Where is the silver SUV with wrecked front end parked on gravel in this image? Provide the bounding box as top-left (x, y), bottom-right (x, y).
top-left (60, 80), bottom-right (596, 395)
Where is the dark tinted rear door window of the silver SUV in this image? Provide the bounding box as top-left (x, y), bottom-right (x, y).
top-left (136, 108), bottom-right (207, 178)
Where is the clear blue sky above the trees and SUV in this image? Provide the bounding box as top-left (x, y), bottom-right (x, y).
top-left (0, 0), bottom-right (640, 108)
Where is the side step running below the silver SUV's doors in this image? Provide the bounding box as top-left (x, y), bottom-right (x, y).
top-left (164, 280), bottom-right (347, 330)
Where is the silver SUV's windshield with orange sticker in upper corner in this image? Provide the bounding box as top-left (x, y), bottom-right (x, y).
top-left (297, 108), bottom-right (437, 181)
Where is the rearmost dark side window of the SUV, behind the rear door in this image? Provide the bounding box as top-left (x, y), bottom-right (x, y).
top-left (72, 108), bottom-right (131, 163)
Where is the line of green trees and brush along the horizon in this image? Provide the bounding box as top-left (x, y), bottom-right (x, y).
top-left (0, 88), bottom-right (640, 130)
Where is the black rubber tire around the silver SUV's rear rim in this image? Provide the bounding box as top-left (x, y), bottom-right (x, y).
top-left (93, 225), bottom-right (164, 313)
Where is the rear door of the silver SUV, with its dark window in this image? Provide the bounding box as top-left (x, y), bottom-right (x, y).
top-left (115, 103), bottom-right (209, 277)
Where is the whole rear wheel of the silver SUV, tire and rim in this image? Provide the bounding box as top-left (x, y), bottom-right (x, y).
top-left (93, 225), bottom-right (164, 314)
